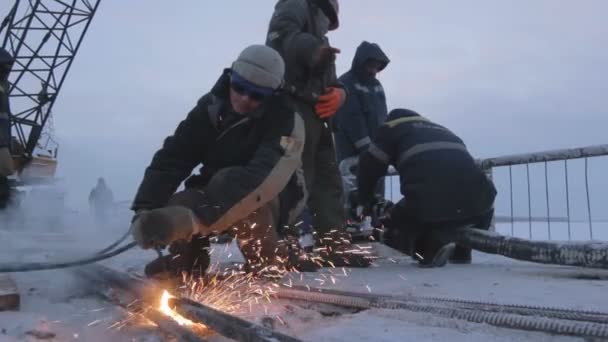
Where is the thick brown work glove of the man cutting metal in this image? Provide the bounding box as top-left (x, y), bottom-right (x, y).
top-left (131, 206), bottom-right (203, 249)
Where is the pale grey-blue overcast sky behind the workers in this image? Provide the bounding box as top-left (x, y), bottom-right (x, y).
top-left (0, 0), bottom-right (608, 205)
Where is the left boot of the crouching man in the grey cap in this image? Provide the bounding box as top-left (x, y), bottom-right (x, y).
top-left (144, 235), bottom-right (211, 280)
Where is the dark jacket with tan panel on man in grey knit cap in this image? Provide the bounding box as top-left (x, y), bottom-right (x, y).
top-left (132, 70), bottom-right (304, 230)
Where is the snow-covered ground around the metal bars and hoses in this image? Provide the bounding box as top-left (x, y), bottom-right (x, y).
top-left (0, 207), bottom-right (608, 342)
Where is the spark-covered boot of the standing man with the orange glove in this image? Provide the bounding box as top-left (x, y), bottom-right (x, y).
top-left (315, 231), bottom-right (372, 267)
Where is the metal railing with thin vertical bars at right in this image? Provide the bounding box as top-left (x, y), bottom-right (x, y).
top-left (387, 144), bottom-right (608, 240)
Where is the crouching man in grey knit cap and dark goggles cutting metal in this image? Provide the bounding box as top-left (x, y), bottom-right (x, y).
top-left (132, 45), bottom-right (316, 278)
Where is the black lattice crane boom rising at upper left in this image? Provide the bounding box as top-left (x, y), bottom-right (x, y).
top-left (0, 0), bottom-right (100, 180)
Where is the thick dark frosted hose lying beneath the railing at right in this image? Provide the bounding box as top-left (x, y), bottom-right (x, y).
top-left (450, 228), bottom-right (608, 269)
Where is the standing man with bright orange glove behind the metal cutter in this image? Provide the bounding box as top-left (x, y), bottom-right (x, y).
top-left (266, 0), bottom-right (369, 266)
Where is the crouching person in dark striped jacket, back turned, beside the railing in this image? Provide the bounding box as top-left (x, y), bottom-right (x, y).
top-left (357, 109), bottom-right (496, 267)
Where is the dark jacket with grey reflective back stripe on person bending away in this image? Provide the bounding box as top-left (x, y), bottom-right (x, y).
top-left (357, 109), bottom-right (496, 222)
